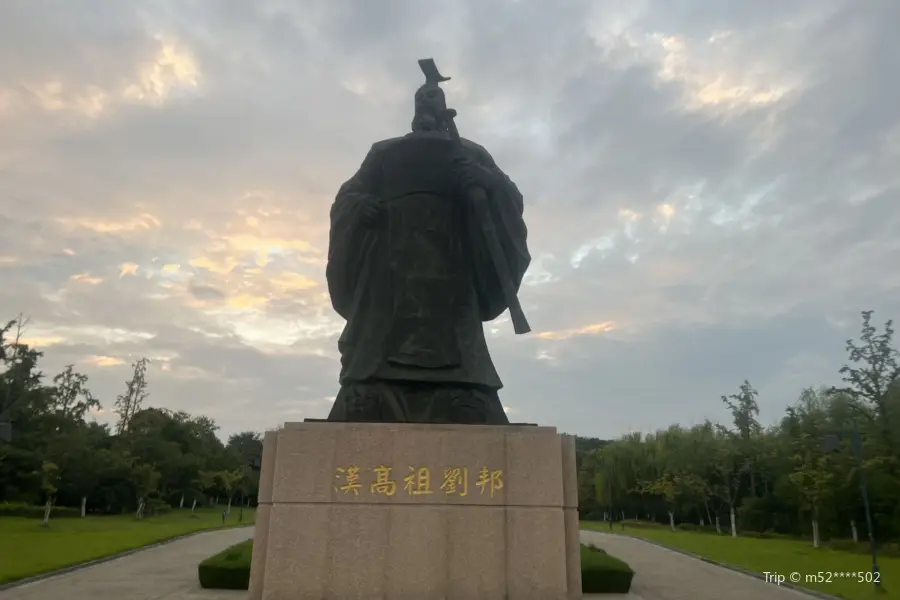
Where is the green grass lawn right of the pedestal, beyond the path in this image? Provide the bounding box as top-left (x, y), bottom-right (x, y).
top-left (581, 521), bottom-right (900, 600)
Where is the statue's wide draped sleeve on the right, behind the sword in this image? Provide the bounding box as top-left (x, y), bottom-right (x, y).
top-left (467, 142), bottom-right (531, 321)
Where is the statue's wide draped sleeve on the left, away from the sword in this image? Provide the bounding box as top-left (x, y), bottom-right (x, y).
top-left (325, 146), bottom-right (380, 320)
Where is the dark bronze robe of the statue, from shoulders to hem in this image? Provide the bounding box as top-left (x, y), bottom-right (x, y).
top-left (326, 133), bottom-right (531, 390)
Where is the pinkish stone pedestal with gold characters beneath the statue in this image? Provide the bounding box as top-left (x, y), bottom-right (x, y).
top-left (250, 423), bottom-right (581, 600)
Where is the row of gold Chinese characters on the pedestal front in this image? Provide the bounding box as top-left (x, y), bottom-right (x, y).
top-left (334, 465), bottom-right (503, 498)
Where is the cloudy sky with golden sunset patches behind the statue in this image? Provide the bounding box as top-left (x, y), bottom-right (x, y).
top-left (0, 0), bottom-right (900, 438)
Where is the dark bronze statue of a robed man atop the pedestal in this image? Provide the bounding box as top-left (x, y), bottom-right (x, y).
top-left (326, 63), bottom-right (531, 425)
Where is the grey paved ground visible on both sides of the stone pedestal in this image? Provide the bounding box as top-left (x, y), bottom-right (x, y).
top-left (0, 527), bottom-right (828, 600)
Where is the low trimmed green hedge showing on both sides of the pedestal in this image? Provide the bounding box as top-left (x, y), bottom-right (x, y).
top-left (197, 540), bottom-right (634, 594)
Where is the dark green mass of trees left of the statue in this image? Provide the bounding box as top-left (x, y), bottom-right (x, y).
top-left (0, 317), bottom-right (262, 517)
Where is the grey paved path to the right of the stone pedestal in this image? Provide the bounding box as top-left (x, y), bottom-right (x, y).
top-left (581, 531), bottom-right (814, 600)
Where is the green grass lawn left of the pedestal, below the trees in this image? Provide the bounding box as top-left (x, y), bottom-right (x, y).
top-left (0, 508), bottom-right (255, 584)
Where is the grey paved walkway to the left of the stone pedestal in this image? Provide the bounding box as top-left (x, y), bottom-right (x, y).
top-left (0, 527), bottom-right (253, 600)
